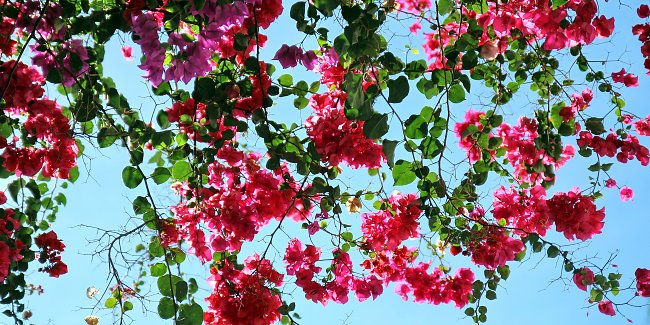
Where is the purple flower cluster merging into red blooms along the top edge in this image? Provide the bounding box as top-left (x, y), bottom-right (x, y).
top-left (128, 0), bottom-right (283, 85)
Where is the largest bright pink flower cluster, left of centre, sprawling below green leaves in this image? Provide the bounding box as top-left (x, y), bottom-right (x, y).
top-left (163, 146), bottom-right (310, 262)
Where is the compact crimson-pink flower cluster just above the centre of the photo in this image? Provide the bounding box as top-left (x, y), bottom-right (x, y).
top-left (305, 90), bottom-right (385, 168)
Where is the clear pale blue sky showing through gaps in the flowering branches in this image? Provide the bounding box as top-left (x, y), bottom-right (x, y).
top-left (8, 1), bottom-right (650, 325)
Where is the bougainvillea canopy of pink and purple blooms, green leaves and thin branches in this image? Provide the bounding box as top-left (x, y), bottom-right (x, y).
top-left (0, 0), bottom-right (650, 325)
